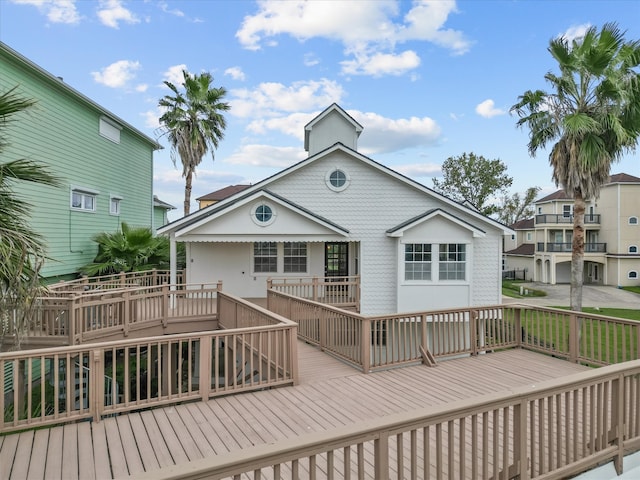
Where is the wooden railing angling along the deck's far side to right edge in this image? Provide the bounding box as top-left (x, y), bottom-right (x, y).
top-left (268, 290), bottom-right (640, 372)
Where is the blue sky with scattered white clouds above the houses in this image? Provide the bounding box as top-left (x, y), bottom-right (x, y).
top-left (0, 0), bottom-right (640, 219)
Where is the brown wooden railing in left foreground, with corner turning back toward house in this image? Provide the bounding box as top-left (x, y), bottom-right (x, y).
top-left (0, 292), bottom-right (297, 432)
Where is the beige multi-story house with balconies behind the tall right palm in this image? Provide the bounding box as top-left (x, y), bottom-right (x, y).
top-left (503, 173), bottom-right (640, 286)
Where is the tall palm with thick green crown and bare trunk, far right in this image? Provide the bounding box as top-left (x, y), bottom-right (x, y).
top-left (511, 23), bottom-right (640, 311)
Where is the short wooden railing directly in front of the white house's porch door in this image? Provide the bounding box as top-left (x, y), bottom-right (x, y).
top-left (267, 275), bottom-right (360, 311)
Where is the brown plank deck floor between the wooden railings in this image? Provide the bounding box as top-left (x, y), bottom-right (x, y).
top-left (0, 342), bottom-right (587, 480)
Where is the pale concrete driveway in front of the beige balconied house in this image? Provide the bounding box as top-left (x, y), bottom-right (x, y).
top-left (502, 283), bottom-right (640, 309)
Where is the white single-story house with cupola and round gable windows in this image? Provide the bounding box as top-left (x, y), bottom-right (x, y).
top-left (159, 104), bottom-right (513, 315)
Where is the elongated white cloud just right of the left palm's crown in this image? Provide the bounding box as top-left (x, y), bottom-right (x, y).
top-left (229, 78), bottom-right (344, 118)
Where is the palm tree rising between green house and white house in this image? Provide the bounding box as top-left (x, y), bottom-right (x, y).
top-left (158, 70), bottom-right (229, 215)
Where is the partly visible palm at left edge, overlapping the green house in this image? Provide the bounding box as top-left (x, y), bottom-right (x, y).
top-left (0, 87), bottom-right (57, 348)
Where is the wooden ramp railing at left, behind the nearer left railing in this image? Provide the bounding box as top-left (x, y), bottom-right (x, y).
top-left (4, 283), bottom-right (222, 345)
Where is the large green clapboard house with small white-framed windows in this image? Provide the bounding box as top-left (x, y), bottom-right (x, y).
top-left (0, 42), bottom-right (160, 281)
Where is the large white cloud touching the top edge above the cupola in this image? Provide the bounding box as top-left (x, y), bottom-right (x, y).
top-left (236, 0), bottom-right (471, 75)
